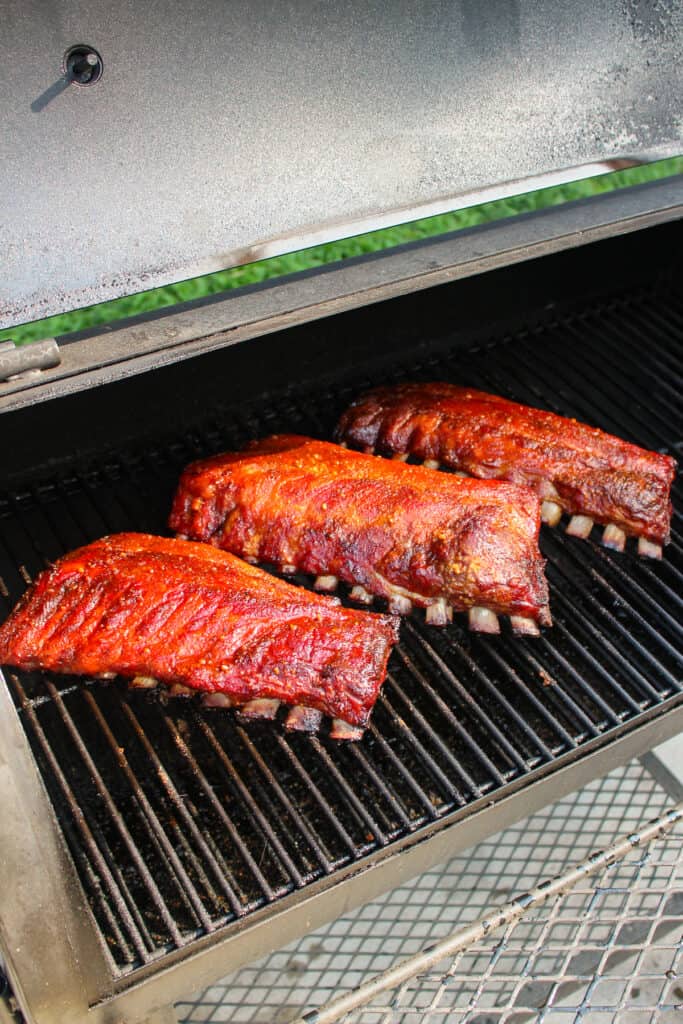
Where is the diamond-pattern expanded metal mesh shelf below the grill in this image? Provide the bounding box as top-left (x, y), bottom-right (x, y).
top-left (176, 762), bottom-right (683, 1024)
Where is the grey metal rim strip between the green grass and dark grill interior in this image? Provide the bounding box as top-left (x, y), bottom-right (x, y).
top-left (0, 175), bottom-right (683, 415)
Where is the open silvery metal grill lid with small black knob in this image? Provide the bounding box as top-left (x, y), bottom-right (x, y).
top-left (0, 0), bottom-right (683, 327)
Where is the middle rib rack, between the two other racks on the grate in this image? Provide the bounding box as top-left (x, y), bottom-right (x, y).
top-left (170, 435), bottom-right (550, 632)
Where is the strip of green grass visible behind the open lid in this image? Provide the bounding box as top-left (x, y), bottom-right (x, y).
top-left (0, 157), bottom-right (683, 344)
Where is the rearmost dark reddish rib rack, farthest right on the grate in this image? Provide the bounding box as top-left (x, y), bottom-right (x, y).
top-left (336, 383), bottom-right (676, 557)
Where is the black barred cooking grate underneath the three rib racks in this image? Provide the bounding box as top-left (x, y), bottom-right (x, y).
top-left (0, 284), bottom-right (683, 975)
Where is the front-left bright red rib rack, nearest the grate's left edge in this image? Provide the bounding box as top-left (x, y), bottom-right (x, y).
top-left (0, 534), bottom-right (397, 726)
